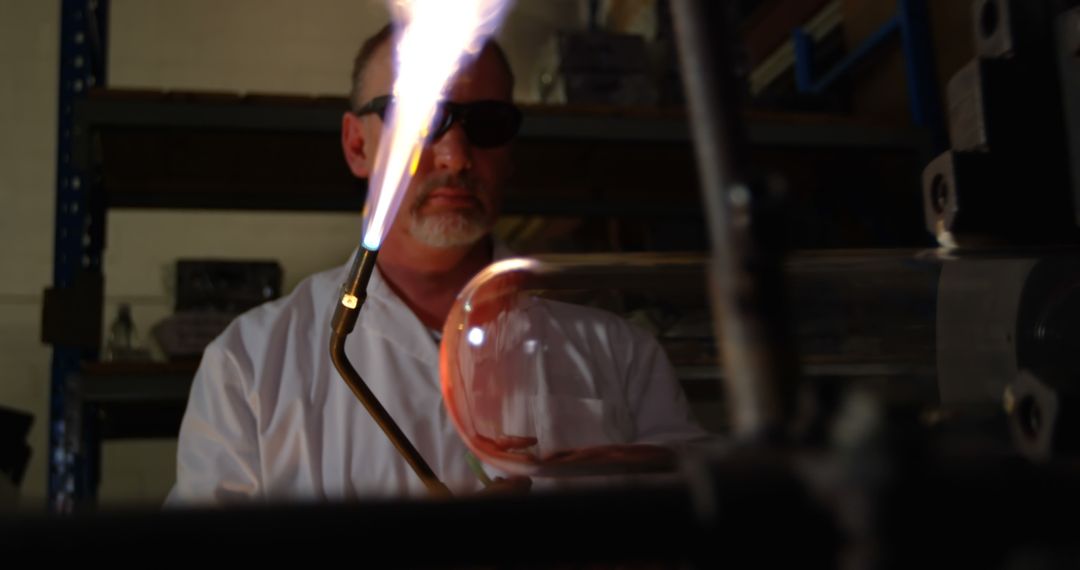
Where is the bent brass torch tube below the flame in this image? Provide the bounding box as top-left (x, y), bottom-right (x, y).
top-left (330, 247), bottom-right (450, 497)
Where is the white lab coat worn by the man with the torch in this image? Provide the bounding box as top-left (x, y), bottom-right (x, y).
top-left (167, 248), bottom-right (705, 505)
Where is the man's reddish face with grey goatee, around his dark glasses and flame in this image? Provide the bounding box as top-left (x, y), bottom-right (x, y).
top-left (347, 43), bottom-right (512, 247)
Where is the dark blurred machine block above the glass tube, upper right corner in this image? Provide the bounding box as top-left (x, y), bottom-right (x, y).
top-left (922, 0), bottom-right (1080, 248)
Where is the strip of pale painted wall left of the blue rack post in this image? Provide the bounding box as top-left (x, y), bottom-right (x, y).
top-left (0, 0), bottom-right (59, 510)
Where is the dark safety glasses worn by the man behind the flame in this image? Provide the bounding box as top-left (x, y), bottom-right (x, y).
top-left (353, 95), bottom-right (522, 148)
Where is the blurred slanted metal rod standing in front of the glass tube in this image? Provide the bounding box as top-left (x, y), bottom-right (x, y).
top-left (672, 0), bottom-right (797, 439)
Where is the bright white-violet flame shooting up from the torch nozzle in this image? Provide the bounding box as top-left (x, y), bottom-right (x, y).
top-left (364, 0), bottom-right (511, 250)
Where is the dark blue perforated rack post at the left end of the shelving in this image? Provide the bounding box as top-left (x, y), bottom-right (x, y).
top-left (48, 0), bottom-right (108, 513)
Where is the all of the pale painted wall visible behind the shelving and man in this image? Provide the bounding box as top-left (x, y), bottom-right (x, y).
top-left (0, 0), bottom-right (584, 508)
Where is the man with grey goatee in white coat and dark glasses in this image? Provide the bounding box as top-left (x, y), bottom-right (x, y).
top-left (170, 27), bottom-right (701, 504)
